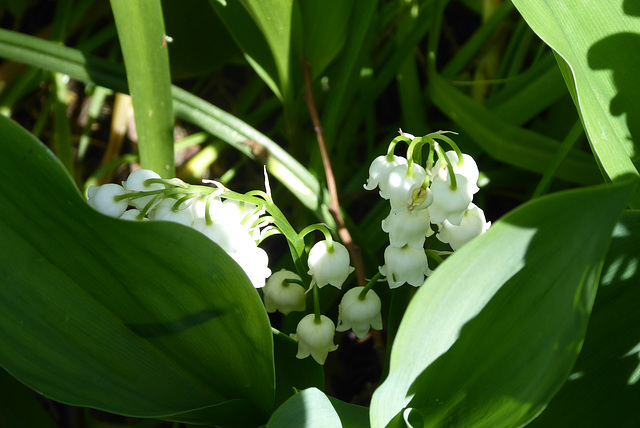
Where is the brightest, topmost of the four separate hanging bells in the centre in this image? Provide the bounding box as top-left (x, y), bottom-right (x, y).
top-left (307, 241), bottom-right (353, 289)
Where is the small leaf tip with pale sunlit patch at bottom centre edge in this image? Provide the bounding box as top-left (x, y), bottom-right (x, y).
top-left (267, 388), bottom-right (369, 428)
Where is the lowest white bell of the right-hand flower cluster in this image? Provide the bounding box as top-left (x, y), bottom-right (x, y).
top-left (379, 245), bottom-right (431, 288)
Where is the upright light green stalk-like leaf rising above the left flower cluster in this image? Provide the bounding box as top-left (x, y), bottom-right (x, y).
top-left (111, 0), bottom-right (176, 178)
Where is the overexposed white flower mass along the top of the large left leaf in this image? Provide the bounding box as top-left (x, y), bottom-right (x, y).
top-left (88, 169), bottom-right (271, 288)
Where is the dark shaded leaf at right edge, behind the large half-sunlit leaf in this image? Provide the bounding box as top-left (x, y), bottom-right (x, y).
top-left (529, 211), bottom-right (640, 428)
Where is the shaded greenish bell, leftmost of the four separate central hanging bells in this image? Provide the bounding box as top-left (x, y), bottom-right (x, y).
top-left (262, 269), bottom-right (306, 315)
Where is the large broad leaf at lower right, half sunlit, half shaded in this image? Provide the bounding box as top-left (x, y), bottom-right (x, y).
top-left (371, 179), bottom-right (633, 427)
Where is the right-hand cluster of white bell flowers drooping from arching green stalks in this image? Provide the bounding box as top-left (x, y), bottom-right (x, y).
top-left (364, 132), bottom-right (490, 288)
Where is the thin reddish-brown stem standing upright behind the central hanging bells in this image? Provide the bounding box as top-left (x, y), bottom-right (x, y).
top-left (302, 59), bottom-right (367, 286)
